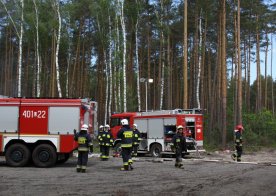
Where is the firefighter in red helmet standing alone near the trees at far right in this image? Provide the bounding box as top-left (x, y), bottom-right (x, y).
top-left (231, 125), bottom-right (244, 162)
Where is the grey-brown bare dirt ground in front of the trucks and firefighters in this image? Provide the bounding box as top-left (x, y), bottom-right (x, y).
top-left (0, 151), bottom-right (276, 196)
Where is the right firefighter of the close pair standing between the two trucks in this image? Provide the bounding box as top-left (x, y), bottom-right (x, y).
top-left (101, 125), bottom-right (113, 161)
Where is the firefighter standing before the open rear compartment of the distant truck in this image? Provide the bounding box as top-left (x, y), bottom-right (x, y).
top-left (172, 125), bottom-right (187, 168)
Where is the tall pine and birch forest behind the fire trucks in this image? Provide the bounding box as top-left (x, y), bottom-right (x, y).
top-left (0, 0), bottom-right (276, 149)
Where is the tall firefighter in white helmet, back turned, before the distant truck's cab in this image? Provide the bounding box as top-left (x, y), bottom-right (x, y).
top-left (117, 119), bottom-right (133, 171)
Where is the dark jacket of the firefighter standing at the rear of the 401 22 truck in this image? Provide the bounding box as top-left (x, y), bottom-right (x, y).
top-left (74, 131), bottom-right (93, 151)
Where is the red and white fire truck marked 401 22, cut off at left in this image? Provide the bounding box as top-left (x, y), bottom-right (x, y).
top-left (0, 97), bottom-right (97, 167)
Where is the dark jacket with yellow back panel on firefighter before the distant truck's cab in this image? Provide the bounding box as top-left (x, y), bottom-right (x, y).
top-left (117, 125), bottom-right (133, 148)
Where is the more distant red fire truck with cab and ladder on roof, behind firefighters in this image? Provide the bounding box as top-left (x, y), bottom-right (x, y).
top-left (110, 109), bottom-right (204, 157)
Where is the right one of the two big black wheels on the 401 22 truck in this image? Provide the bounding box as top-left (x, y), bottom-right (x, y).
top-left (32, 144), bottom-right (57, 167)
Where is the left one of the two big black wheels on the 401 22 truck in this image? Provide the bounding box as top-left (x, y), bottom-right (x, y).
top-left (5, 144), bottom-right (31, 167)
